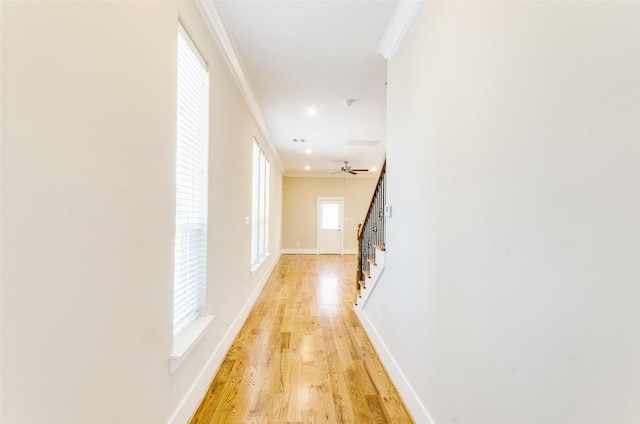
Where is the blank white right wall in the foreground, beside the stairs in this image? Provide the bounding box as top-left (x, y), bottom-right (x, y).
top-left (365, 1), bottom-right (640, 424)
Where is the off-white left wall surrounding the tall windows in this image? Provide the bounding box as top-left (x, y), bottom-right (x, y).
top-left (0, 1), bottom-right (282, 424)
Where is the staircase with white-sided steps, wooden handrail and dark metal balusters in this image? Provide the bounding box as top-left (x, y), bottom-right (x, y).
top-left (355, 161), bottom-right (387, 308)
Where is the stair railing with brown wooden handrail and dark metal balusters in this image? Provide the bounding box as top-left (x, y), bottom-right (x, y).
top-left (356, 160), bottom-right (387, 303)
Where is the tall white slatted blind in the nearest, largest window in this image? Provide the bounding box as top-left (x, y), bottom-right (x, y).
top-left (173, 28), bottom-right (209, 334)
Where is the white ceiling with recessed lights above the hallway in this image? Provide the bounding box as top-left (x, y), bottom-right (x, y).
top-left (207, 0), bottom-right (398, 177)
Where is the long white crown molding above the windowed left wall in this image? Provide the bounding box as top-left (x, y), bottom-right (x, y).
top-left (193, 0), bottom-right (284, 172)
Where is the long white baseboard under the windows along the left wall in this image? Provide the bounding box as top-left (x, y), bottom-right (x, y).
top-left (167, 255), bottom-right (280, 424)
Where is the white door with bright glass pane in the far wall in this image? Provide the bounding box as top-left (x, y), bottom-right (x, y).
top-left (318, 197), bottom-right (344, 255)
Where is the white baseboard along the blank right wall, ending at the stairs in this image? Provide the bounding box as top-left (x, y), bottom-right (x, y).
top-left (354, 306), bottom-right (435, 424)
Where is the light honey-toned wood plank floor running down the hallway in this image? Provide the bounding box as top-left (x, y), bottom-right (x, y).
top-left (191, 255), bottom-right (414, 424)
